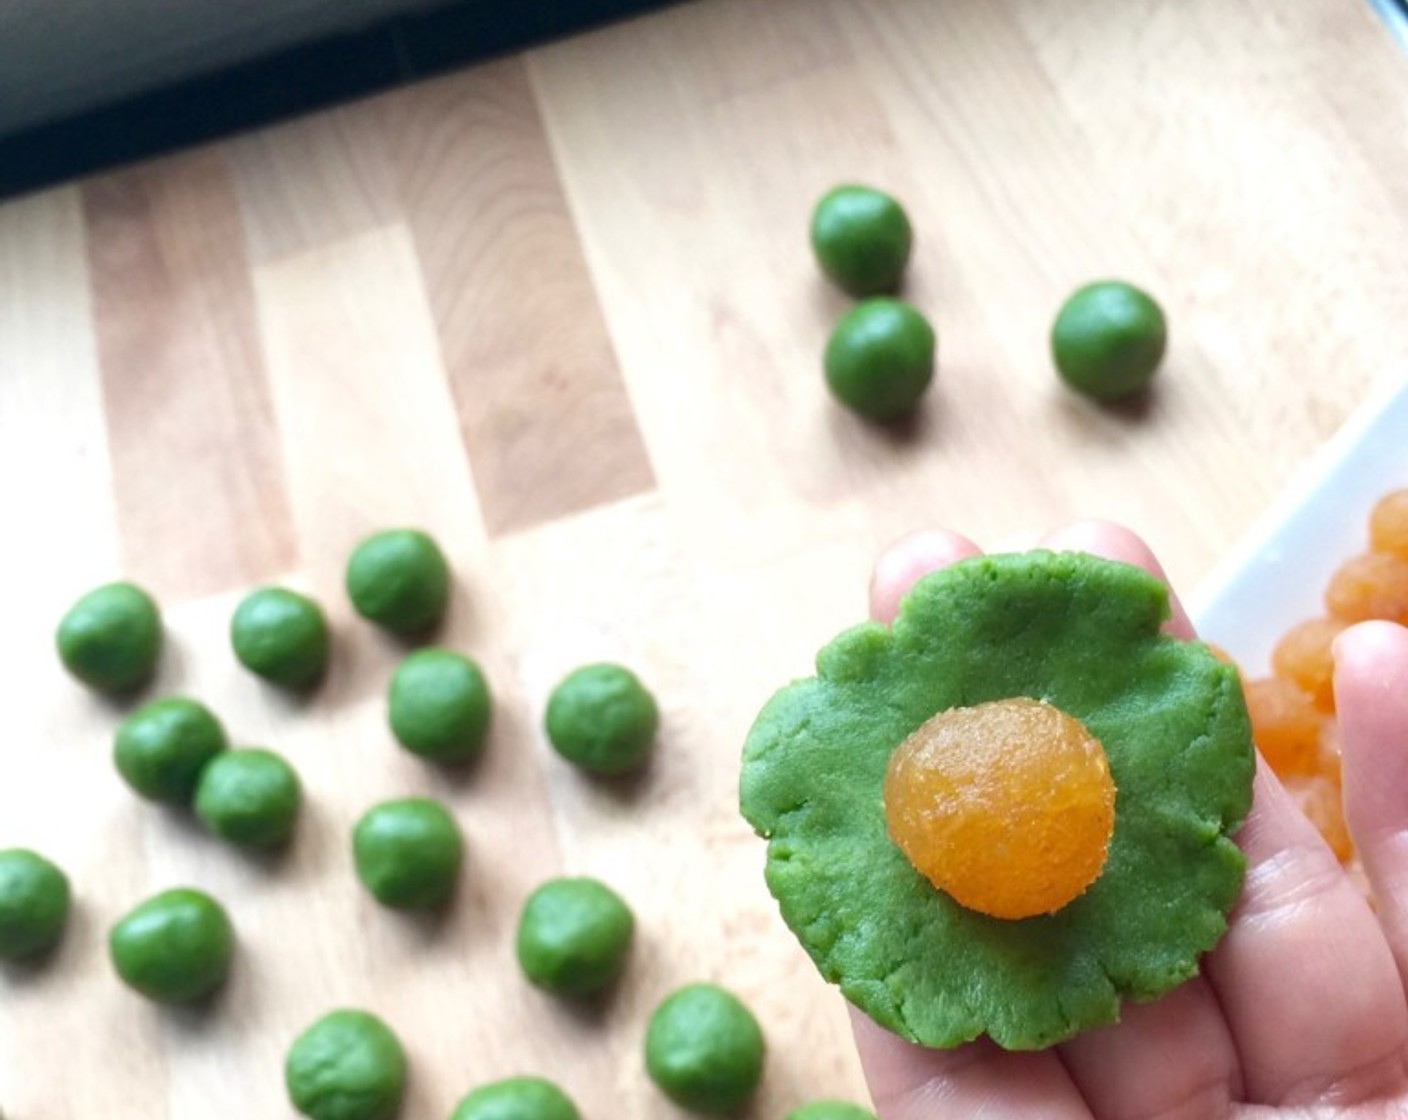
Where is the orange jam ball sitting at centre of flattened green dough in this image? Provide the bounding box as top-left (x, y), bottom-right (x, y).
top-left (884, 697), bottom-right (1115, 919)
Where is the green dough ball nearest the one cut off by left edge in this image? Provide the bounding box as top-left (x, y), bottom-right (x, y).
top-left (107, 888), bottom-right (235, 1003)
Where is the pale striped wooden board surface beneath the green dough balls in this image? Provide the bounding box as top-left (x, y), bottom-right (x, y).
top-left (0, 0), bottom-right (1408, 1120)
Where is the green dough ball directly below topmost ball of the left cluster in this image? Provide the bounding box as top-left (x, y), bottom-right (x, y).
top-left (387, 649), bottom-right (493, 762)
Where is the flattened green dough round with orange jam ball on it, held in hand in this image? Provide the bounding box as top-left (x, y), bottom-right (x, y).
top-left (739, 552), bottom-right (1255, 1050)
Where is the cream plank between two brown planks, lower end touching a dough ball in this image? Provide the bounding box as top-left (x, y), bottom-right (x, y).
top-left (255, 225), bottom-right (484, 608)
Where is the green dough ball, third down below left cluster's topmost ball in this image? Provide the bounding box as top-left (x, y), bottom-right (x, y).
top-left (352, 797), bottom-right (465, 910)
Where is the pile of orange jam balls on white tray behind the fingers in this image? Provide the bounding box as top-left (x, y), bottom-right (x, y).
top-left (1245, 490), bottom-right (1408, 864)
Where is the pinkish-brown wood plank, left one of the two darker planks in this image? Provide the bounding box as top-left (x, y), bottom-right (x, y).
top-left (83, 149), bottom-right (296, 596)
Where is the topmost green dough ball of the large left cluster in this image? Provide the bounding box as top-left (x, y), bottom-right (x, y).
top-left (346, 528), bottom-right (449, 635)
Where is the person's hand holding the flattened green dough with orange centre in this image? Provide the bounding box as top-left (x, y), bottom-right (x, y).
top-left (852, 521), bottom-right (1408, 1120)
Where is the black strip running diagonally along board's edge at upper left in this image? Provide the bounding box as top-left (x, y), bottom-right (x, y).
top-left (0, 0), bottom-right (670, 197)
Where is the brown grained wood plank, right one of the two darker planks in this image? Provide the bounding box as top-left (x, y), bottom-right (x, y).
top-left (393, 59), bottom-right (653, 534)
